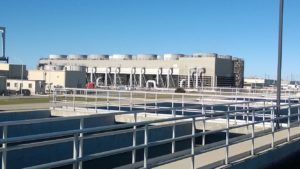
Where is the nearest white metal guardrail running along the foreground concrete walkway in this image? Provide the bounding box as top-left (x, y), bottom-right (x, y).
top-left (0, 89), bottom-right (300, 169)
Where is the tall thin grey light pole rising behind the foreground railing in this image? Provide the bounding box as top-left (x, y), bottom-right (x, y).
top-left (276, 0), bottom-right (284, 129)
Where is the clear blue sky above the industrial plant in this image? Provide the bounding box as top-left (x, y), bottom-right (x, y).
top-left (0, 0), bottom-right (300, 80)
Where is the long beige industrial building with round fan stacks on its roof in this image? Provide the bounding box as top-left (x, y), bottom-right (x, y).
top-left (38, 53), bottom-right (244, 88)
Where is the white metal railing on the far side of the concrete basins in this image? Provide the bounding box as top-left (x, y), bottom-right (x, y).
top-left (50, 88), bottom-right (298, 112)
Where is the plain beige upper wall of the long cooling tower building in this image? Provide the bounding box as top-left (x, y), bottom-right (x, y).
top-left (40, 57), bottom-right (233, 76)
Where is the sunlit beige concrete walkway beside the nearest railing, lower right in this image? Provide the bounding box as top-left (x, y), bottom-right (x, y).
top-left (155, 127), bottom-right (300, 169)
